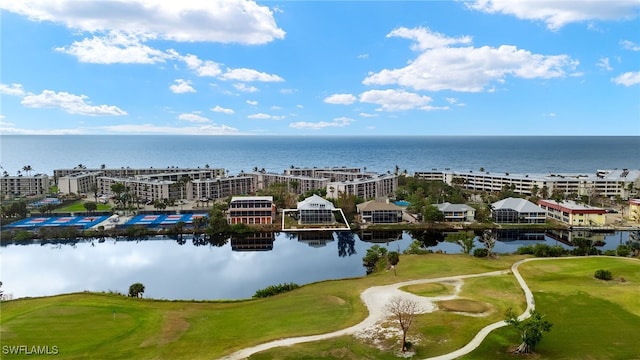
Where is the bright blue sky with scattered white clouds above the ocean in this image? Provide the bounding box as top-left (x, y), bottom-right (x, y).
top-left (0, 0), bottom-right (640, 136)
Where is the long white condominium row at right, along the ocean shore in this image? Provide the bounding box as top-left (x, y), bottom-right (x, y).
top-left (414, 169), bottom-right (640, 199)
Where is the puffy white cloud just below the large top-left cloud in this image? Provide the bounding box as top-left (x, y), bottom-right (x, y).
top-left (56, 31), bottom-right (169, 64)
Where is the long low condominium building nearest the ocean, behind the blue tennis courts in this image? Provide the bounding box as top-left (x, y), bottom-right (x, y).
top-left (53, 166), bottom-right (226, 179)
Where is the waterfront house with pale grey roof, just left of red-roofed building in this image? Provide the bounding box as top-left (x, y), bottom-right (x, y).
top-left (491, 197), bottom-right (547, 224)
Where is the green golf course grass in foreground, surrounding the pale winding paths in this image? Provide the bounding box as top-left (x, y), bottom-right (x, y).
top-left (0, 254), bottom-right (640, 359)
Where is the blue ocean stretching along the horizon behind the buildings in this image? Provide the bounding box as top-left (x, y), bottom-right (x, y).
top-left (0, 135), bottom-right (640, 175)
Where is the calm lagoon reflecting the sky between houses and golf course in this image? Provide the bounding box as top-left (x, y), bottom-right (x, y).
top-left (0, 230), bottom-right (640, 299)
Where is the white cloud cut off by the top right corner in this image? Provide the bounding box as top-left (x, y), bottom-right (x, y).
top-left (467, 0), bottom-right (640, 30)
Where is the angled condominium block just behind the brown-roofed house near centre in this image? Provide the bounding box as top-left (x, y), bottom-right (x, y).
top-left (327, 174), bottom-right (398, 200)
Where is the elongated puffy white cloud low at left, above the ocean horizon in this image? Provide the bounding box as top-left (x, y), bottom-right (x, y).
top-left (21, 90), bottom-right (127, 116)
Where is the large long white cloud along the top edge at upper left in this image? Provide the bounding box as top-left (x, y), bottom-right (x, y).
top-left (0, 0), bottom-right (285, 44)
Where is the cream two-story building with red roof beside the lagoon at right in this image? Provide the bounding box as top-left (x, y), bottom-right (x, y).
top-left (538, 200), bottom-right (607, 226)
